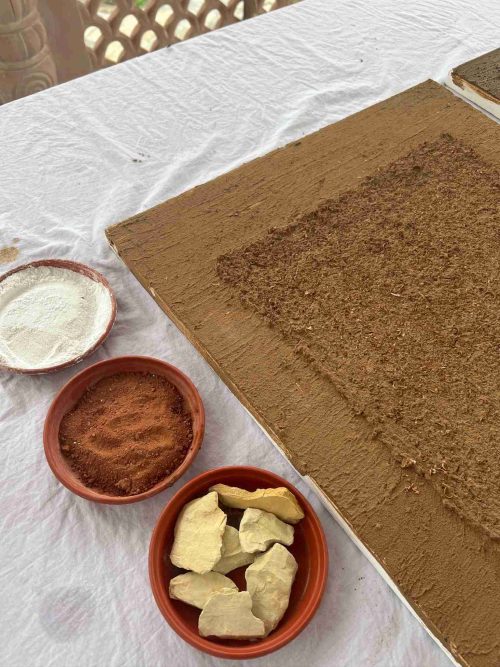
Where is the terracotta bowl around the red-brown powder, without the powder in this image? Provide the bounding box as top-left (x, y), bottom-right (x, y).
top-left (43, 357), bottom-right (205, 505)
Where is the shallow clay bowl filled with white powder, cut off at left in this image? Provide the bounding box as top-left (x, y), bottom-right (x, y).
top-left (0, 259), bottom-right (116, 375)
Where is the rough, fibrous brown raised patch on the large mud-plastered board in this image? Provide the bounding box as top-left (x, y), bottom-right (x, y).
top-left (217, 135), bottom-right (500, 539)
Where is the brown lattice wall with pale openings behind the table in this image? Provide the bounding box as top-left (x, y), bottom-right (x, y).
top-left (78, 0), bottom-right (296, 69)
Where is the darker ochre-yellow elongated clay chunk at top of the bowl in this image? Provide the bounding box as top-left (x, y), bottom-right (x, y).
top-left (210, 484), bottom-right (304, 523)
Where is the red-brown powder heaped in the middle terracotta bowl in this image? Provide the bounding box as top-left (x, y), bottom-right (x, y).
top-left (59, 373), bottom-right (193, 495)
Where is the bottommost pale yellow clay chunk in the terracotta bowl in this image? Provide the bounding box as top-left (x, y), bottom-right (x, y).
top-left (198, 589), bottom-right (265, 639)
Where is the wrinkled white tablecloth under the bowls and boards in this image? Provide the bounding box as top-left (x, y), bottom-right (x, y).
top-left (0, 0), bottom-right (500, 667)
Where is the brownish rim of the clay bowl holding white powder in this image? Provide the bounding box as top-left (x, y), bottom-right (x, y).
top-left (0, 259), bottom-right (116, 375)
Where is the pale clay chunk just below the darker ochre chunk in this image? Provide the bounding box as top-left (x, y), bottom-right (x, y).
top-left (240, 507), bottom-right (294, 553)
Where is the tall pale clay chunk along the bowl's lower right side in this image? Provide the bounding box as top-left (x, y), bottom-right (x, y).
top-left (245, 544), bottom-right (297, 635)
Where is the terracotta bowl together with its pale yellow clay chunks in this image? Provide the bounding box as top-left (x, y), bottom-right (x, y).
top-left (149, 466), bottom-right (328, 660)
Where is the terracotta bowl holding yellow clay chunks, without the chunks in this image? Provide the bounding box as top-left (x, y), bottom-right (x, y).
top-left (149, 466), bottom-right (328, 659)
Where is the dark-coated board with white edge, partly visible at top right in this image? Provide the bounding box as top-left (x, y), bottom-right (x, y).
top-left (446, 49), bottom-right (500, 119)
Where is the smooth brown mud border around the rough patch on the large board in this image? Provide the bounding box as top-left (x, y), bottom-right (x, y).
top-left (107, 82), bottom-right (500, 667)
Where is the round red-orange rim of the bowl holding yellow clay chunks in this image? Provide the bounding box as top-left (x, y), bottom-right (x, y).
top-left (148, 466), bottom-right (328, 660)
